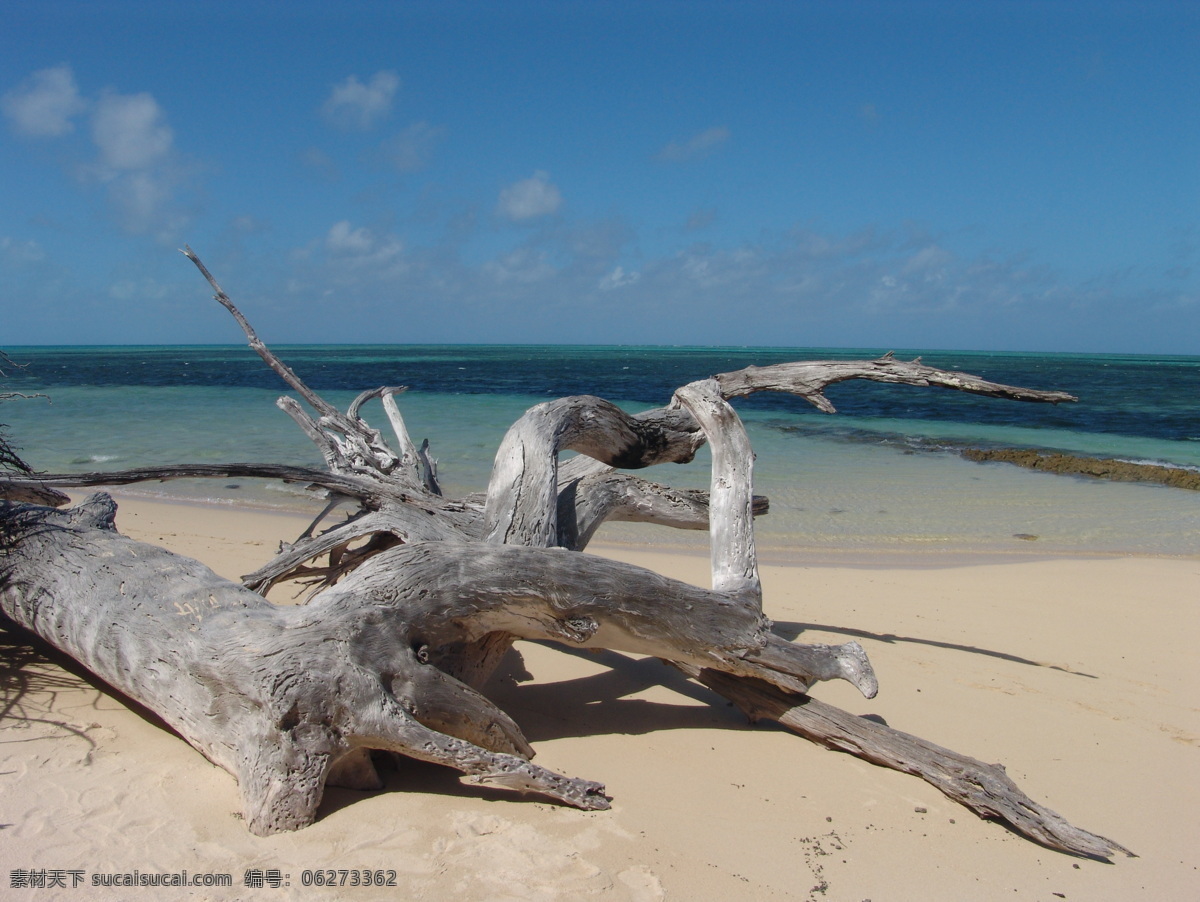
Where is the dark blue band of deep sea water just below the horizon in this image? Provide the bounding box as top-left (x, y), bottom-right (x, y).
top-left (7, 345), bottom-right (1200, 464)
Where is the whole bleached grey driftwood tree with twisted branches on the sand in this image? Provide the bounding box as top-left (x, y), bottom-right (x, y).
top-left (0, 251), bottom-right (1127, 858)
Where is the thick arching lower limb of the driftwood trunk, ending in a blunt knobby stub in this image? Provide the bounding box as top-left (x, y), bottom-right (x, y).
top-left (306, 542), bottom-right (877, 697)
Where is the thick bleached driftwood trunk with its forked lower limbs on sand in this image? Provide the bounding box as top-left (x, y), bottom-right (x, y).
top-left (0, 495), bottom-right (872, 834)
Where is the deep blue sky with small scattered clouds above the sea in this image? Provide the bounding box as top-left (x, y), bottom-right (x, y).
top-left (0, 0), bottom-right (1200, 354)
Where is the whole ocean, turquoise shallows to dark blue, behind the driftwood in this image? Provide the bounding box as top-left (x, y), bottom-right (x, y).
top-left (0, 345), bottom-right (1200, 558)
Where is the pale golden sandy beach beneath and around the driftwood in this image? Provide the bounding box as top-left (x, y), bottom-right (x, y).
top-left (0, 499), bottom-right (1200, 902)
